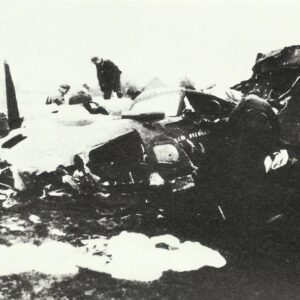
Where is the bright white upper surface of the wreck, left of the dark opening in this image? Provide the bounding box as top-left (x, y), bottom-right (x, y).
top-left (0, 117), bottom-right (133, 190)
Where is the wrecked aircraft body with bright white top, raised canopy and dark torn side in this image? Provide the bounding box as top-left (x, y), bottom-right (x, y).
top-left (0, 63), bottom-right (239, 197)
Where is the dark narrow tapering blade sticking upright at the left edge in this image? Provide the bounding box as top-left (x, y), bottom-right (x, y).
top-left (4, 62), bottom-right (22, 129)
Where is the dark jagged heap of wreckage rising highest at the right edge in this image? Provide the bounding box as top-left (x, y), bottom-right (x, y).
top-left (232, 45), bottom-right (300, 151)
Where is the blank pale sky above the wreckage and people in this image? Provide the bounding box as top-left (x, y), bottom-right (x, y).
top-left (0, 0), bottom-right (300, 97)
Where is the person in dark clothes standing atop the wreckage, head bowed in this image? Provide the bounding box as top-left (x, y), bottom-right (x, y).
top-left (91, 56), bottom-right (123, 99)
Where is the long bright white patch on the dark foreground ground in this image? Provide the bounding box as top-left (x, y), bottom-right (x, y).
top-left (0, 231), bottom-right (226, 281)
